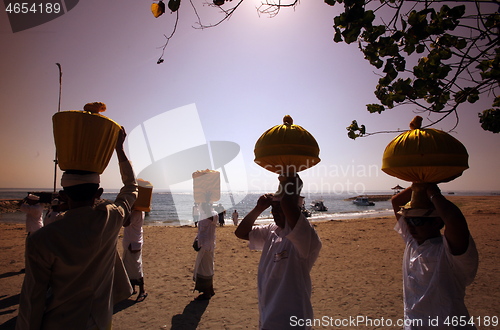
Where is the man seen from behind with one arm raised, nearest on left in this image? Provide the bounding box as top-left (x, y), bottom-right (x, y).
top-left (16, 128), bottom-right (137, 330)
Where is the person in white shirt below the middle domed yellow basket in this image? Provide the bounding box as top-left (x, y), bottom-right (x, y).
top-left (235, 175), bottom-right (322, 330)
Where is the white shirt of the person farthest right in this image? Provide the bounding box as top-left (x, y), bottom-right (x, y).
top-left (394, 217), bottom-right (478, 329)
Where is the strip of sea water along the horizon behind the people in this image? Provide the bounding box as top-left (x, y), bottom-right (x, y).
top-left (0, 189), bottom-right (498, 226)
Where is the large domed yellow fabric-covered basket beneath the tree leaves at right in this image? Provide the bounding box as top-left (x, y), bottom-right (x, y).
top-left (382, 128), bottom-right (469, 183)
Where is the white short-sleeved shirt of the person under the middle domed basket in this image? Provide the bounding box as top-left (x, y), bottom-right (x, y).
top-left (249, 215), bottom-right (321, 330)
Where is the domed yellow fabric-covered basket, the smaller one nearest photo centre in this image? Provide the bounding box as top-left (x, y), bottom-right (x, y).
top-left (254, 118), bottom-right (321, 174)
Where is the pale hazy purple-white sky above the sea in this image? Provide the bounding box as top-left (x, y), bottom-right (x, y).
top-left (0, 0), bottom-right (500, 193)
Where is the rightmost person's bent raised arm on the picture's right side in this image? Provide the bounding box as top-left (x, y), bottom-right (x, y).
top-left (427, 184), bottom-right (470, 255)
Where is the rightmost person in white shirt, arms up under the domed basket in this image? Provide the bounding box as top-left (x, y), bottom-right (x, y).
top-left (392, 183), bottom-right (478, 329)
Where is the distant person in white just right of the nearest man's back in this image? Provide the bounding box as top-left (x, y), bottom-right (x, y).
top-left (122, 207), bottom-right (148, 302)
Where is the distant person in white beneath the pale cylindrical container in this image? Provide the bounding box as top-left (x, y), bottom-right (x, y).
top-left (193, 203), bottom-right (219, 300)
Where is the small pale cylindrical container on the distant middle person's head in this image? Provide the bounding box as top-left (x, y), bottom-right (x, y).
top-left (192, 170), bottom-right (220, 203)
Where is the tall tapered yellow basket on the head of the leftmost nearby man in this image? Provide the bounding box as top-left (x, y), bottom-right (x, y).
top-left (52, 111), bottom-right (121, 174)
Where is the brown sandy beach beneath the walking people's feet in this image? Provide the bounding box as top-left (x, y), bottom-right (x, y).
top-left (0, 196), bottom-right (500, 330)
